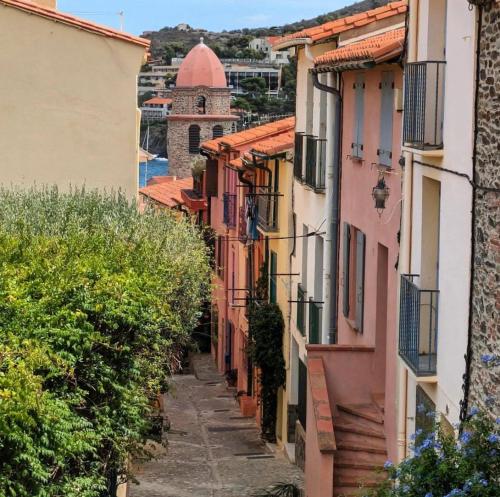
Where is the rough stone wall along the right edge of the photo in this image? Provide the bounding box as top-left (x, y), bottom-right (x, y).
top-left (469, 2), bottom-right (500, 417)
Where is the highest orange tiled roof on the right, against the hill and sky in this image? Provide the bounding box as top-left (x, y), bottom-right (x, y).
top-left (273, 0), bottom-right (407, 47)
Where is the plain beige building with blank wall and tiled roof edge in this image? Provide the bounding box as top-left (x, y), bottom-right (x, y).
top-left (0, 0), bottom-right (150, 198)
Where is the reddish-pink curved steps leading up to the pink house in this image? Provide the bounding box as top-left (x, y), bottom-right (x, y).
top-left (333, 402), bottom-right (387, 497)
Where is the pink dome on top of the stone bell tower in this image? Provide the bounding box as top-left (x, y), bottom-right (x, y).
top-left (176, 38), bottom-right (227, 88)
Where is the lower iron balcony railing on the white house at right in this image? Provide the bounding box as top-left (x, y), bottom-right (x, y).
top-left (399, 274), bottom-right (439, 376)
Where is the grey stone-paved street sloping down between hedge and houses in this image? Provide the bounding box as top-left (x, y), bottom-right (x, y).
top-left (129, 355), bottom-right (302, 497)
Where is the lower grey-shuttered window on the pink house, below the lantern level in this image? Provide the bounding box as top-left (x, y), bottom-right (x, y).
top-left (342, 223), bottom-right (366, 333)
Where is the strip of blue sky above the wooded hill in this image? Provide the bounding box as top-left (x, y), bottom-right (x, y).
top-left (58, 0), bottom-right (355, 34)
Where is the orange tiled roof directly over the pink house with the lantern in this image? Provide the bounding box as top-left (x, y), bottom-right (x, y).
top-left (314, 28), bottom-right (405, 65)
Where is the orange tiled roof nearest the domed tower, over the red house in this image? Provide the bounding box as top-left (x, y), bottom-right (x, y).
top-left (201, 117), bottom-right (295, 152)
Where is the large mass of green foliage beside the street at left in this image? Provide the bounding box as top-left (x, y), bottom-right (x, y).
top-left (0, 188), bottom-right (210, 497)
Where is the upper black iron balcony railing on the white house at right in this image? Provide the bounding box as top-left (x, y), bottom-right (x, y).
top-left (403, 61), bottom-right (446, 150)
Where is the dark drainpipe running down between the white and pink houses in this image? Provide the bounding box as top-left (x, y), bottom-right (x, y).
top-left (313, 71), bottom-right (342, 343)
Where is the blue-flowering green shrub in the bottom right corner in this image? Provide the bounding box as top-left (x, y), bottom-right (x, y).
top-left (374, 408), bottom-right (500, 497)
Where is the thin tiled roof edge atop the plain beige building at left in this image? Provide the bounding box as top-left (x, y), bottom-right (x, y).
top-left (0, 0), bottom-right (151, 48)
